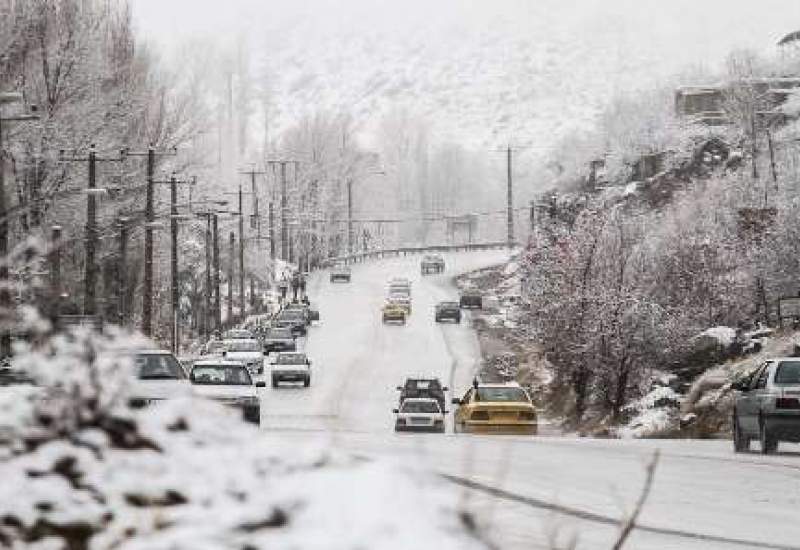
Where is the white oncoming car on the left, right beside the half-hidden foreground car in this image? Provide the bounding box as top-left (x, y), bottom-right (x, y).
top-left (189, 359), bottom-right (264, 424)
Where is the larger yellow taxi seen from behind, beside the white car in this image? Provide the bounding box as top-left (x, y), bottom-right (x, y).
top-left (453, 382), bottom-right (538, 435)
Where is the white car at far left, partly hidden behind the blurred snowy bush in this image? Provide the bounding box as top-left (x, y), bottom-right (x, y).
top-left (130, 350), bottom-right (190, 408)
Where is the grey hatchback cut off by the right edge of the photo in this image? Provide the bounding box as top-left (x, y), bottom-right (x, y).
top-left (732, 357), bottom-right (800, 454)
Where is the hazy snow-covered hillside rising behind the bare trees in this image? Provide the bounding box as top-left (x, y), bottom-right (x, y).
top-left (251, 0), bottom-right (797, 149)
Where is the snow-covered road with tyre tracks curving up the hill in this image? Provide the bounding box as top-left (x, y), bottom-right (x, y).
top-left (262, 251), bottom-right (800, 550)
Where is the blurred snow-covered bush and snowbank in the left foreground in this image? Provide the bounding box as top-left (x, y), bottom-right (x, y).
top-left (0, 333), bottom-right (487, 550)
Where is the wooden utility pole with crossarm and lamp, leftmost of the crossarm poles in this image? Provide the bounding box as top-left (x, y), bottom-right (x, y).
top-left (59, 144), bottom-right (127, 315)
